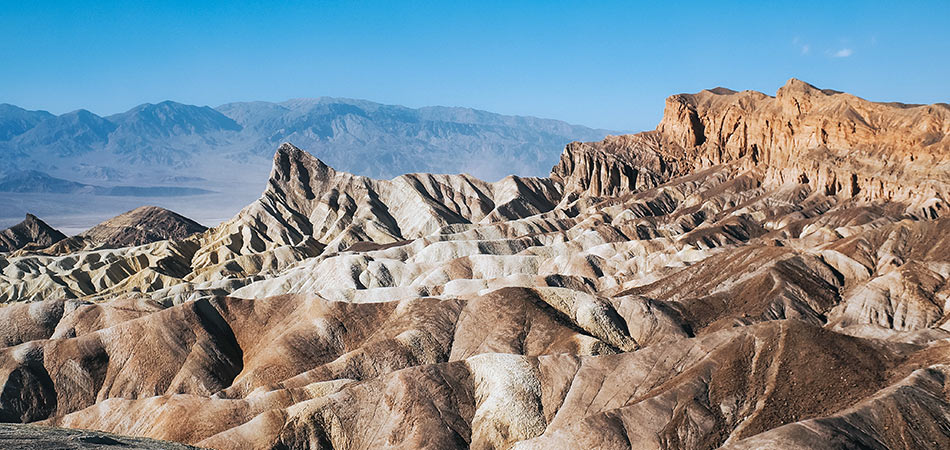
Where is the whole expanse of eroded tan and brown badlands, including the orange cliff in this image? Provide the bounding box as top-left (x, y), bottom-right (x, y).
top-left (0, 80), bottom-right (950, 449)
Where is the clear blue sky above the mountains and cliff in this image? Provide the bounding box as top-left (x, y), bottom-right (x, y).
top-left (0, 0), bottom-right (950, 130)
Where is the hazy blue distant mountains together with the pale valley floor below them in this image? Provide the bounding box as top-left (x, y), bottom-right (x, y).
top-left (0, 97), bottom-right (611, 232)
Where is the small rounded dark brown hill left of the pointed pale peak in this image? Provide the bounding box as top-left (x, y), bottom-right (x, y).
top-left (80, 206), bottom-right (207, 248)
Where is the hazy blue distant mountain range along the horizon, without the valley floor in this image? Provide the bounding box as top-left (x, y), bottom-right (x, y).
top-left (0, 97), bottom-right (609, 182)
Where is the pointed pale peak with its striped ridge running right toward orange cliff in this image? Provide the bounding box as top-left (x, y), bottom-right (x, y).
top-left (193, 143), bottom-right (560, 278)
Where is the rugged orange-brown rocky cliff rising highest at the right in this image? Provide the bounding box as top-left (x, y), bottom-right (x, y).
top-left (552, 79), bottom-right (950, 216)
